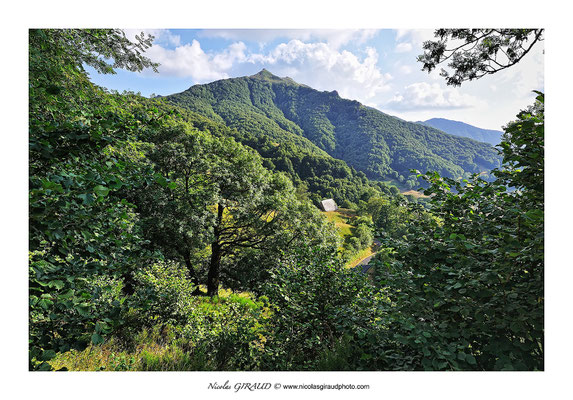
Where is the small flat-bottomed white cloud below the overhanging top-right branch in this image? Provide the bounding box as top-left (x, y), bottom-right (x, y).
top-left (385, 82), bottom-right (479, 111)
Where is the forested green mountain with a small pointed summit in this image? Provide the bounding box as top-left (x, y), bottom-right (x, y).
top-left (166, 70), bottom-right (500, 187)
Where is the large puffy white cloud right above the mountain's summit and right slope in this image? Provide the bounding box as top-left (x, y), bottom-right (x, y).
top-left (249, 40), bottom-right (392, 102)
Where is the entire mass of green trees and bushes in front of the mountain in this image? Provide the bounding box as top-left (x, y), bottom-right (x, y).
top-left (29, 29), bottom-right (544, 370)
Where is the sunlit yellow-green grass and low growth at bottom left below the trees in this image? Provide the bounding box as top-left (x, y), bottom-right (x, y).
top-left (49, 289), bottom-right (272, 371)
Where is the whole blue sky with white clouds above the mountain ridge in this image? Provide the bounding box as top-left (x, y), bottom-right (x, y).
top-left (90, 29), bottom-right (544, 129)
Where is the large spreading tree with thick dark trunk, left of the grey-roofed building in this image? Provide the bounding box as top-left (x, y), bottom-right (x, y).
top-left (134, 128), bottom-right (336, 296)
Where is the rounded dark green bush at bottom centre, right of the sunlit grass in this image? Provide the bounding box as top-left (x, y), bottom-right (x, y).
top-left (262, 248), bottom-right (384, 370)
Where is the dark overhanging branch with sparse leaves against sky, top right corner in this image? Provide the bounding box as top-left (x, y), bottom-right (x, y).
top-left (418, 29), bottom-right (544, 86)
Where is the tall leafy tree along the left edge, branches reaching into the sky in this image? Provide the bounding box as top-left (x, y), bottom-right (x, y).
top-left (29, 29), bottom-right (161, 369)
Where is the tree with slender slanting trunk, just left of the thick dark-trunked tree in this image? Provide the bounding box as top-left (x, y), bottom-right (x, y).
top-left (127, 123), bottom-right (215, 290)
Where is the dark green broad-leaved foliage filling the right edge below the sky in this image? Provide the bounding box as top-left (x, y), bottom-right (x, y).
top-left (379, 94), bottom-right (544, 370)
